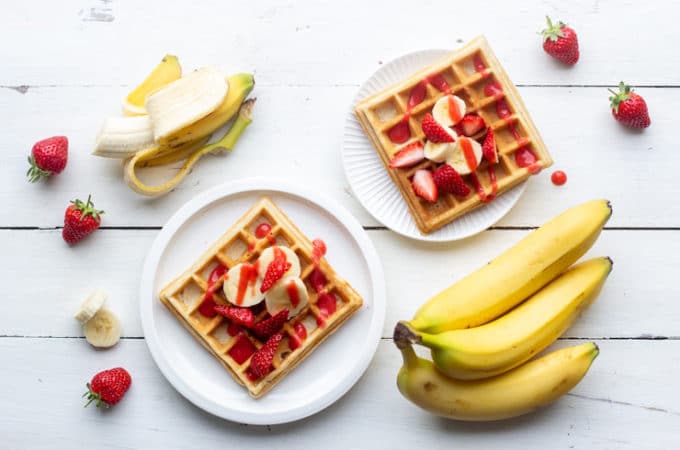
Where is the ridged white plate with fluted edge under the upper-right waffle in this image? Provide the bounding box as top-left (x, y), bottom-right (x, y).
top-left (342, 49), bottom-right (527, 242)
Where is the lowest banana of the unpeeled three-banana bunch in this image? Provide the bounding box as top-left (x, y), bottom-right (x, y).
top-left (397, 342), bottom-right (599, 421)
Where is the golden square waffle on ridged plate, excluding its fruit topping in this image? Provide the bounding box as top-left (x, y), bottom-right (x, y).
top-left (354, 36), bottom-right (552, 234)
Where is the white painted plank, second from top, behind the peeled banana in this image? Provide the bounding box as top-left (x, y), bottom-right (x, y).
top-left (0, 86), bottom-right (680, 227)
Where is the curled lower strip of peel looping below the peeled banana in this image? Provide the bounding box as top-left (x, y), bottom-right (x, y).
top-left (123, 98), bottom-right (255, 197)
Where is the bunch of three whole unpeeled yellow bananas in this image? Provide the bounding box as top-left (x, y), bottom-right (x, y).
top-left (394, 200), bottom-right (612, 421)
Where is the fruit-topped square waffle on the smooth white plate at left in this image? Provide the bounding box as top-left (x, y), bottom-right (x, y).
top-left (160, 197), bottom-right (363, 398)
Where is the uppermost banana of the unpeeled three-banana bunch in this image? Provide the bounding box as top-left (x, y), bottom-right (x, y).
top-left (407, 200), bottom-right (612, 333)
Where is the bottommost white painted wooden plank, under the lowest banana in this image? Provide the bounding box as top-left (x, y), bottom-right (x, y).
top-left (0, 338), bottom-right (680, 450)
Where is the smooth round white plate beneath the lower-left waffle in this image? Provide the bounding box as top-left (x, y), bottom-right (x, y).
top-left (140, 179), bottom-right (385, 425)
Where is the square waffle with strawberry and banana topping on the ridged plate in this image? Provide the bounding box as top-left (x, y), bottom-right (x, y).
top-left (354, 36), bottom-right (552, 234)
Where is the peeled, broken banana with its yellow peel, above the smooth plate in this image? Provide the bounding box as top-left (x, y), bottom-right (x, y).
top-left (93, 55), bottom-right (255, 196)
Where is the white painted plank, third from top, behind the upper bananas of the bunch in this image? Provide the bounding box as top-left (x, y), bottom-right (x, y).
top-left (0, 229), bottom-right (680, 338)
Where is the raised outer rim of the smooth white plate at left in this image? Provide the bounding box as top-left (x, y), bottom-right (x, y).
top-left (139, 177), bottom-right (386, 425)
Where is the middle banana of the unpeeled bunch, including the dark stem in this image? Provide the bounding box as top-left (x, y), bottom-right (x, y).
top-left (394, 258), bottom-right (612, 380)
